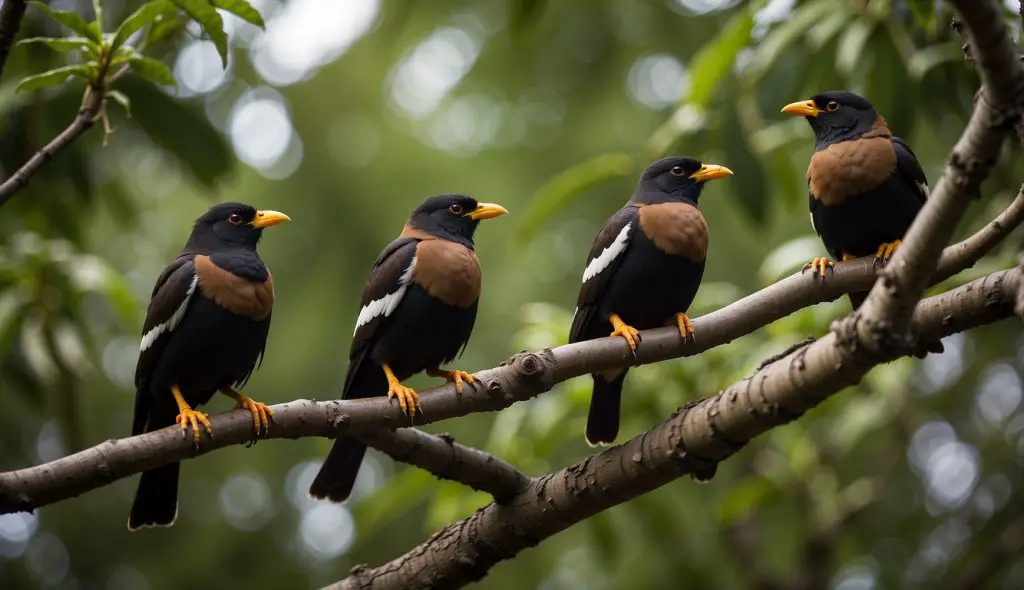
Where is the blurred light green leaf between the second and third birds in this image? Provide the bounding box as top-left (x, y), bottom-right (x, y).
top-left (513, 154), bottom-right (633, 244)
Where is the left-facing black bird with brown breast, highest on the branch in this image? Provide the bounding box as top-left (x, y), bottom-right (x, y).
top-left (782, 91), bottom-right (942, 352)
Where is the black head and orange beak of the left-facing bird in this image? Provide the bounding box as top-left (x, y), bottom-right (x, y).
top-left (782, 91), bottom-right (879, 150)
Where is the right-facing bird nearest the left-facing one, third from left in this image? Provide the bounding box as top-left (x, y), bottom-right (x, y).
top-left (569, 158), bottom-right (732, 445)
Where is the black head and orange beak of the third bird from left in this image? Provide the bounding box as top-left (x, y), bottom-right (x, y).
top-left (631, 156), bottom-right (732, 205)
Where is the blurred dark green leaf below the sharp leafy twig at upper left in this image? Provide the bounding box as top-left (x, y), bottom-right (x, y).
top-left (118, 76), bottom-right (237, 186)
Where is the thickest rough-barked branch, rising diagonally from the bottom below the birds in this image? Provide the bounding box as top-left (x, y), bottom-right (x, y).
top-left (327, 268), bottom-right (1021, 590)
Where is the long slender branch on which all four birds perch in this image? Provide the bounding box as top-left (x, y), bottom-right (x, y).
top-left (0, 195), bottom-right (1024, 513)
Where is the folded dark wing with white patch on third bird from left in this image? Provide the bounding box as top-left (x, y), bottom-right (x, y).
top-left (569, 207), bottom-right (637, 342)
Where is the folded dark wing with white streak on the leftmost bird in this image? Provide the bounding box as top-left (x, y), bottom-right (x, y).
top-left (132, 254), bottom-right (198, 434)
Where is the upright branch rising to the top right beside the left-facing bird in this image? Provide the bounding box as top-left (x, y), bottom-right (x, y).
top-left (851, 0), bottom-right (1024, 346)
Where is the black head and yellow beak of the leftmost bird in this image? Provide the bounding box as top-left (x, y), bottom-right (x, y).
top-left (185, 203), bottom-right (289, 254)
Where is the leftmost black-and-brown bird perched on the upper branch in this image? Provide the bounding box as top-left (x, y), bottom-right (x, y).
top-left (128, 203), bottom-right (289, 531)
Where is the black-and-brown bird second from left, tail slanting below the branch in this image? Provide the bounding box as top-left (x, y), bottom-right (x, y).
top-left (309, 195), bottom-right (508, 502)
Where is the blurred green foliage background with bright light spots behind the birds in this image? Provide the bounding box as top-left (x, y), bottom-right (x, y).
top-left (0, 0), bottom-right (1024, 590)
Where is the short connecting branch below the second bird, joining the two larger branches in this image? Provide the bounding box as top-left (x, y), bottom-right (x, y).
top-left (359, 428), bottom-right (532, 503)
